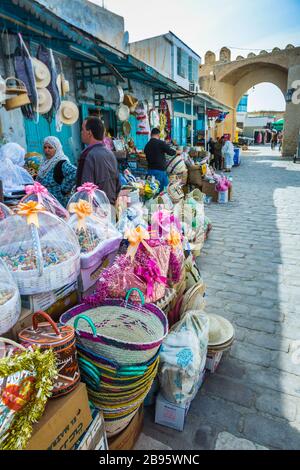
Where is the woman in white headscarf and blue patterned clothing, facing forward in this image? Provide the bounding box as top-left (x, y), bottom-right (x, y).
top-left (36, 136), bottom-right (77, 207)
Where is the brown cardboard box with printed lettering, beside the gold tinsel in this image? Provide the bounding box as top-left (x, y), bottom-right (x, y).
top-left (26, 383), bottom-right (92, 450)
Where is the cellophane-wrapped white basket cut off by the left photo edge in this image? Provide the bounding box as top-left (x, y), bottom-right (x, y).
top-left (0, 260), bottom-right (21, 335)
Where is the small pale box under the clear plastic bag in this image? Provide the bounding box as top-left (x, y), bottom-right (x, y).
top-left (155, 393), bottom-right (191, 431)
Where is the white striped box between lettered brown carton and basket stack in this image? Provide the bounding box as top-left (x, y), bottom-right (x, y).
top-left (74, 409), bottom-right (108, 450)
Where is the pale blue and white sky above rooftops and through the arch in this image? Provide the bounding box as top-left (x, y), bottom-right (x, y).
top-left (93, 0), bottom-right (300, 109)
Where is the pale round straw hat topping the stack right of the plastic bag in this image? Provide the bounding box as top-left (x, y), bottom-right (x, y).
top-left (207, 314), bottom-right (234, 349)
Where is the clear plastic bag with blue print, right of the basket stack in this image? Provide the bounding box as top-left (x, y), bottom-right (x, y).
top-left (159, 311), bottom-right (209, 404)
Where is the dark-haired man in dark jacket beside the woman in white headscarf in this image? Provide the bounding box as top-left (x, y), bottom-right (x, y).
top-left (76, 116), bottom-right (120, 204)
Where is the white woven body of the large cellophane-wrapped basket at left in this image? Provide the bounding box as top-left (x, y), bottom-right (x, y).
top-left (1, 242), bottom-right (80, 295)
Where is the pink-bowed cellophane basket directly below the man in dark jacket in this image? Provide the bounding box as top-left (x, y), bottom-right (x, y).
top-left (67, 183), bottom-right (112, 221)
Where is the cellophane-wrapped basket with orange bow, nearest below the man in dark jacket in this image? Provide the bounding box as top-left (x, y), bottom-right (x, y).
top-left (68, 199), bottom-right (122, 268)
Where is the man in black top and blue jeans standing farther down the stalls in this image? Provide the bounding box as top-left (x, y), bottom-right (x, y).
top-left (144, 128), bottom-right (177, 191)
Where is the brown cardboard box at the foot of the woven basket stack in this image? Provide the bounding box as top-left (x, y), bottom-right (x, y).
top-left (108, 406), bottom-right (144, 450)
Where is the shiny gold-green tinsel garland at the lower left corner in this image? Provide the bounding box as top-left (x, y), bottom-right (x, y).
top-left (0, 348), bottom-right (57, 450)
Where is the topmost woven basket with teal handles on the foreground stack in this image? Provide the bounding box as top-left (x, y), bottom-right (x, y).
top-left (60, 289), bottom-right (168, 365)
